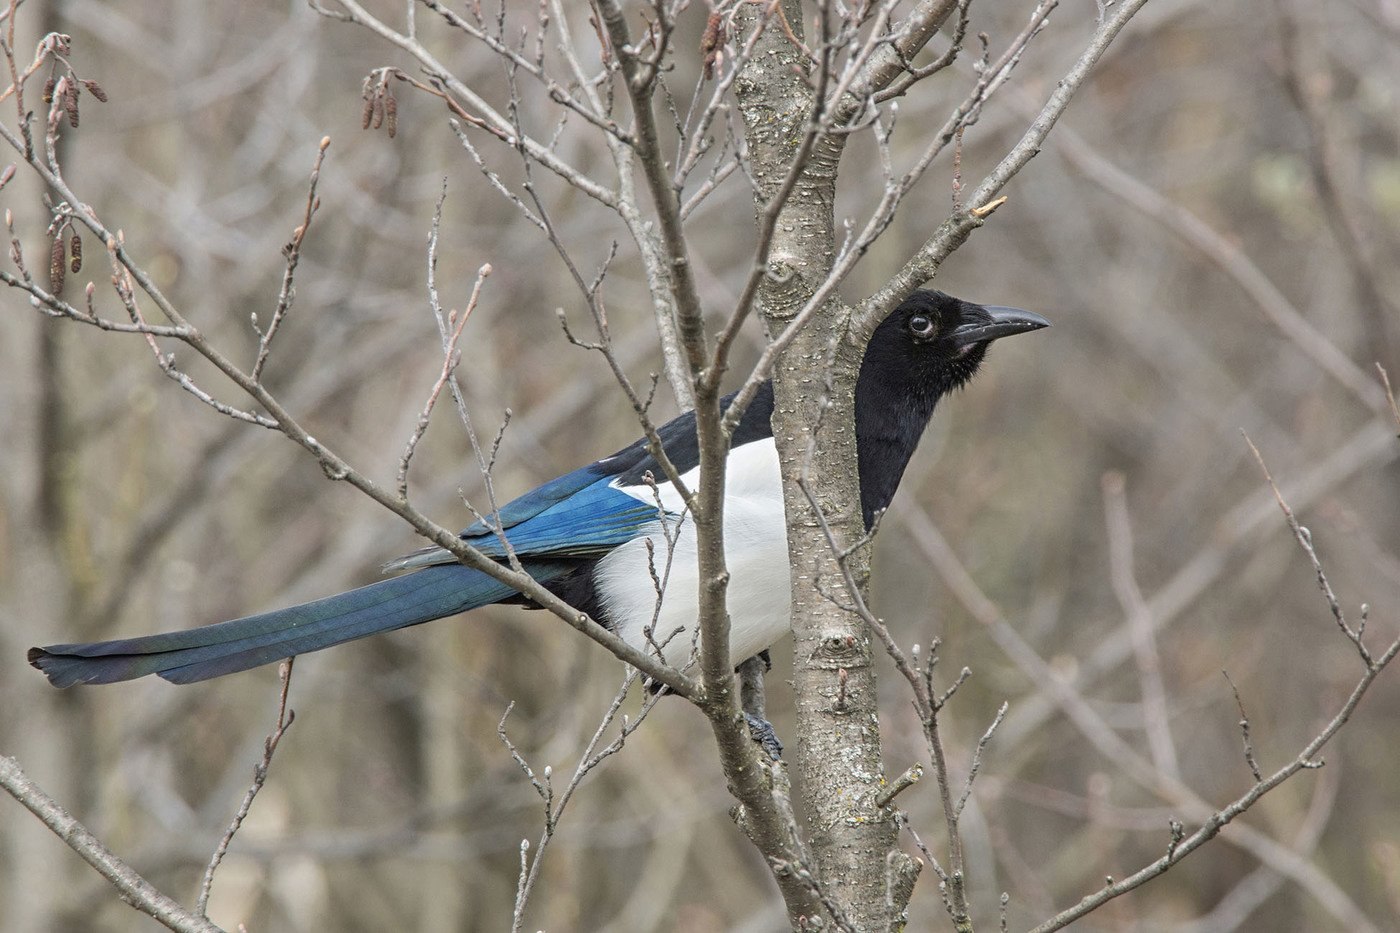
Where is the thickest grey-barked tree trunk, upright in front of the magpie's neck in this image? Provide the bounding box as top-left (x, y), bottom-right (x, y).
top-left (736, 3), bottom-right (909, 930)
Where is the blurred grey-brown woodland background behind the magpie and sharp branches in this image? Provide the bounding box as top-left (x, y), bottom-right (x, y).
top-left (0, 0), bottom-right (1400, 932)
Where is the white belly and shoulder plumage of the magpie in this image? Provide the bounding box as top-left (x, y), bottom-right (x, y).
top-left (594, 438), bottom-right (790, 665)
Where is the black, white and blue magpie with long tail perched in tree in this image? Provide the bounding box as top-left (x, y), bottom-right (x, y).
top-left (28, 290), bottom-right (1050, 686)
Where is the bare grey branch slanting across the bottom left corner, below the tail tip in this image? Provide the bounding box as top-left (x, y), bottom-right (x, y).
top-left (0, 755), bottom-right (223, 933)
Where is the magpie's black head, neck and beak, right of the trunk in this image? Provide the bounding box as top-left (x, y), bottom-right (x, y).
top-left (855, 290), bottom-right (1050, 528)
